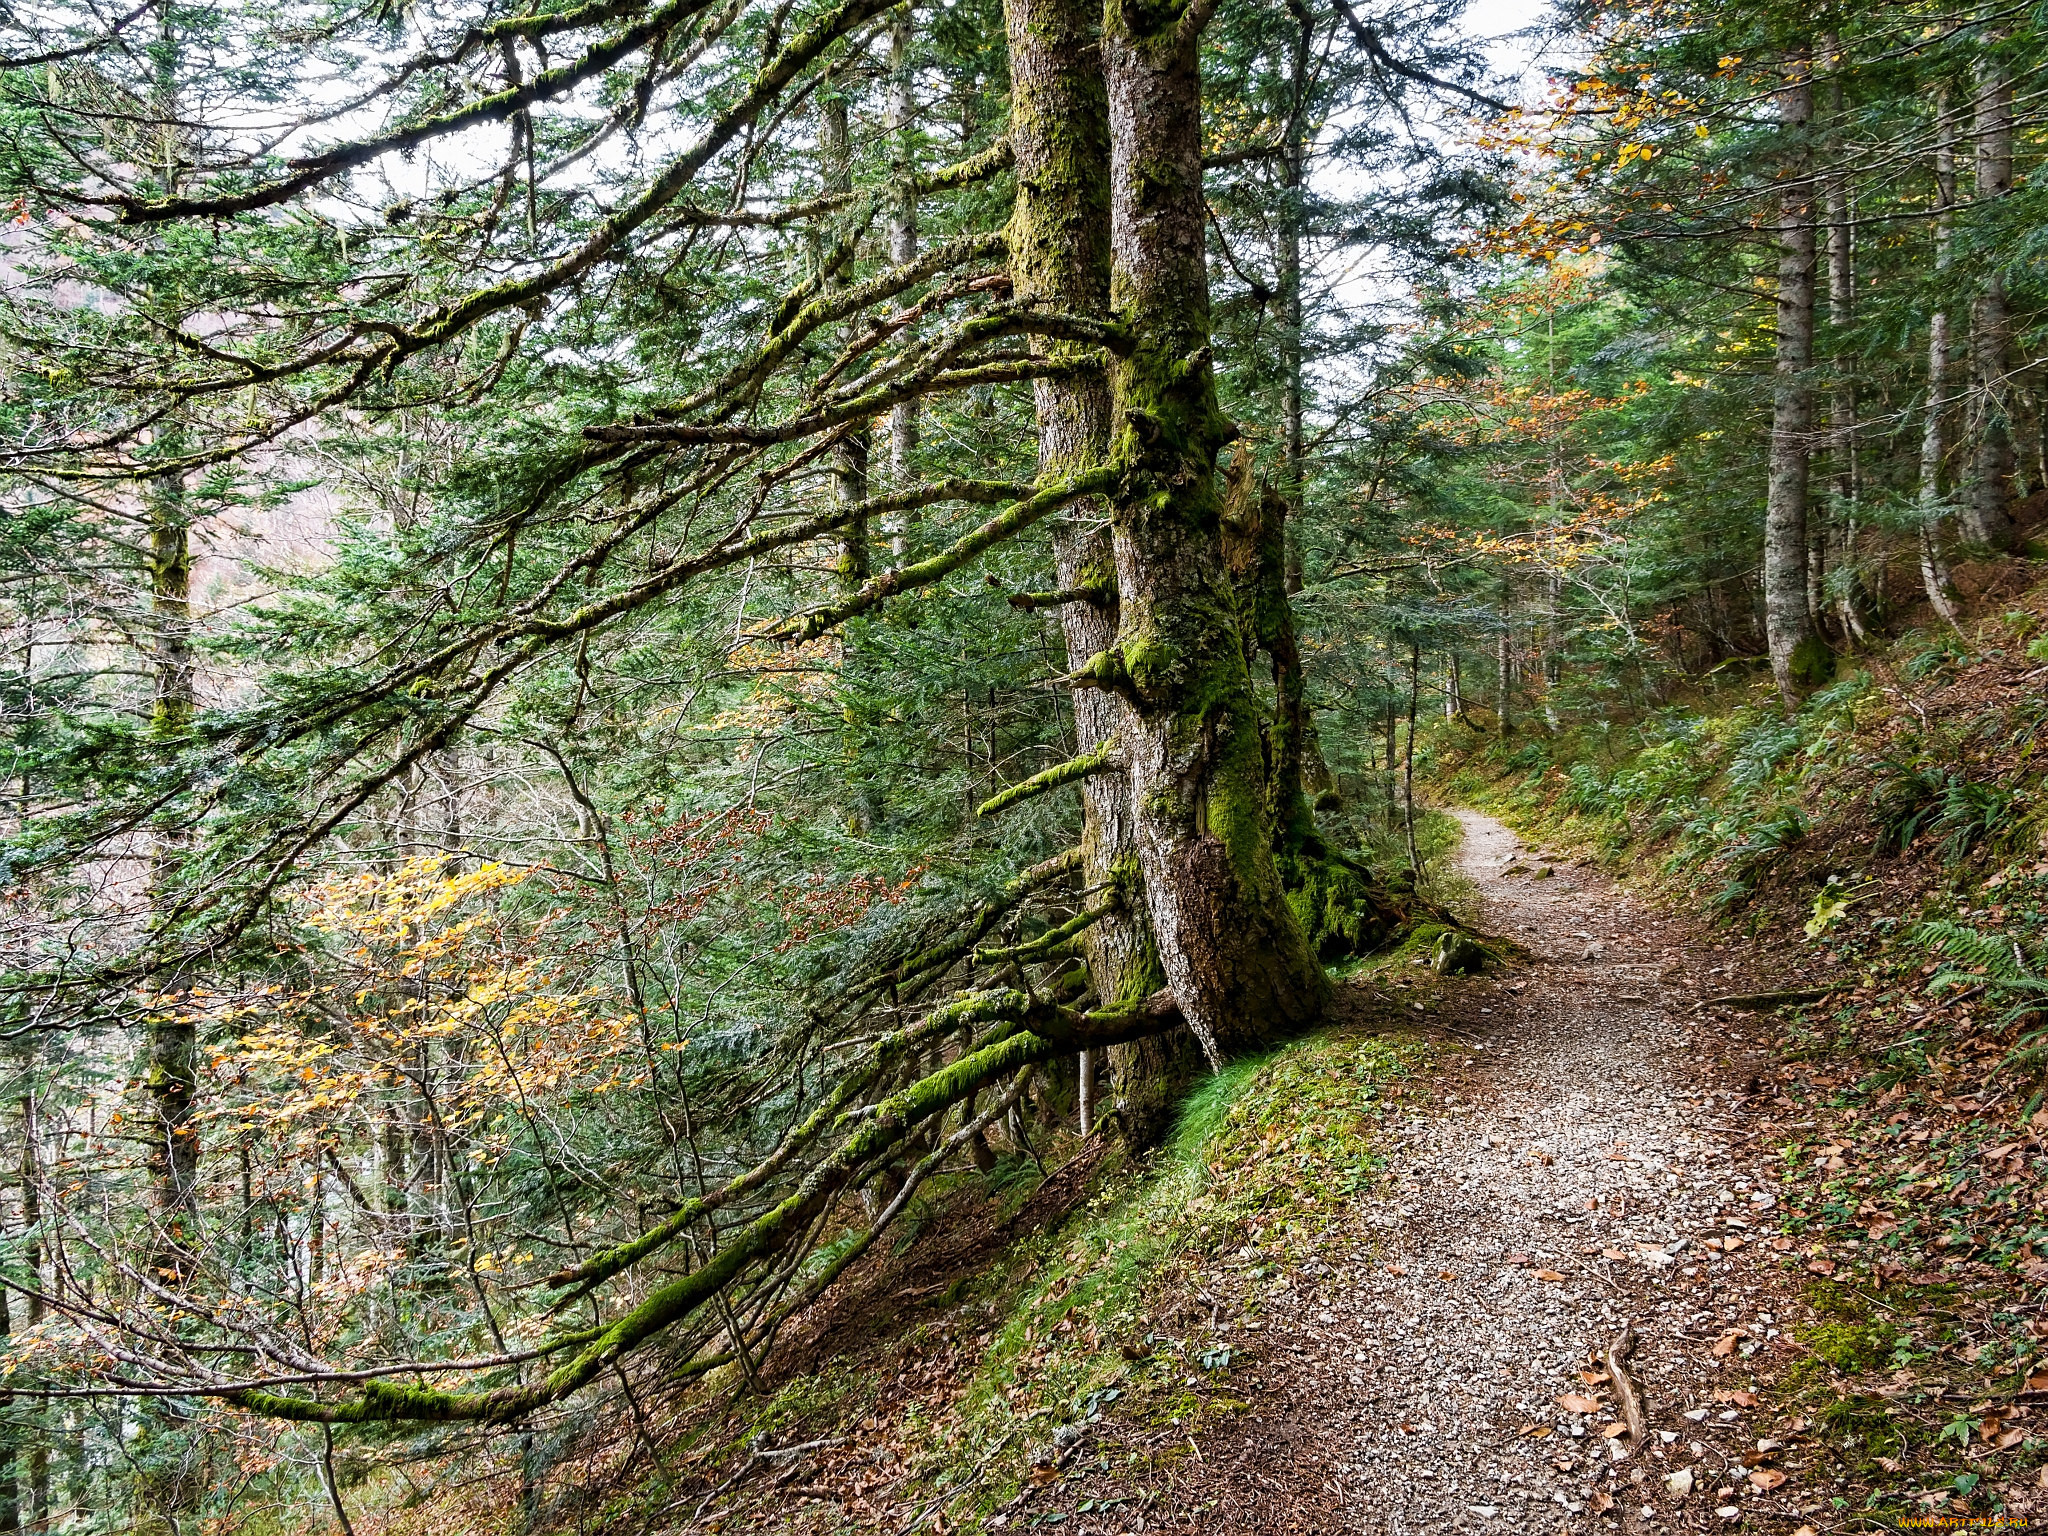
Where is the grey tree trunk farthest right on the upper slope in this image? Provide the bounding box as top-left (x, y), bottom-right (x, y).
top-left (1962, 39), bottom-right (2013, 549)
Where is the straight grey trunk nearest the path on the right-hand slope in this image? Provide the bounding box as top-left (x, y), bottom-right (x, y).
top-left (1763, 57), bottom-right (1827, 711)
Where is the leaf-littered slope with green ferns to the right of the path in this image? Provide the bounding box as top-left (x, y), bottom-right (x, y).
top-left (1430, 586), bottom-right (2048, 1516)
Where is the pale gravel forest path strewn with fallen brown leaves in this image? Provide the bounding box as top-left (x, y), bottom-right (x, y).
top-left (1067, 811), bottom-right (1810, 1536)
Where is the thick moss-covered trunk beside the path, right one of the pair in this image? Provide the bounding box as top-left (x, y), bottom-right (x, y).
top-left (1087, 0), bottom-right (1329, 1063)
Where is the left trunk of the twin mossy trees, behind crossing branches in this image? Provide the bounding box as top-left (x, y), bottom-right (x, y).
top-left (1006, 0), bottom-right (1186, 1145)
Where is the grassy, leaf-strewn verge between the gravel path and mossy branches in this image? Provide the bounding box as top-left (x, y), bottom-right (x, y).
top-left (926, 1032), bottom-right (1425, 1520)
